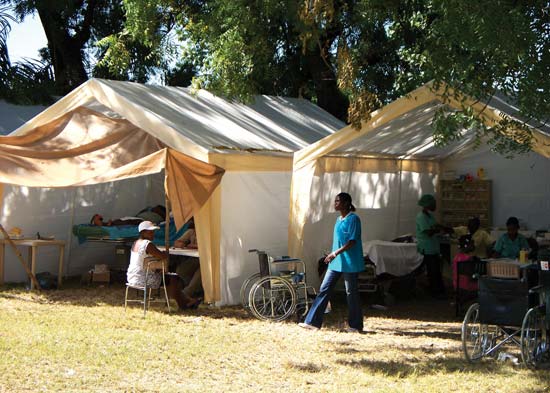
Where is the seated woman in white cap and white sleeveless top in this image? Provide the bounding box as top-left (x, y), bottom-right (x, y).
top-left (126, 221), bottom-right (200, 309)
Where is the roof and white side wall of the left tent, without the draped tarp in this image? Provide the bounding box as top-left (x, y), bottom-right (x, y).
top-left (1, 79), bottom-right (343, 304)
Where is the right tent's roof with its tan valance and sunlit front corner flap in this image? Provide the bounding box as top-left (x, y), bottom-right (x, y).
top-left (289, 82), bottom-right (550, 257)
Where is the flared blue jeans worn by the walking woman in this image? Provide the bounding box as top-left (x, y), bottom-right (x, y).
top-left (304, 270), bottom-right (363, 330)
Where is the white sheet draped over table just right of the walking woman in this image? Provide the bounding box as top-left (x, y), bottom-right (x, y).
top-left (363, 240), bottom-right (423, 276)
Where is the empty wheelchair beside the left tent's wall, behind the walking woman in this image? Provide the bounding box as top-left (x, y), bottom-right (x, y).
top-left (240, 249), bottom-right (316, 322)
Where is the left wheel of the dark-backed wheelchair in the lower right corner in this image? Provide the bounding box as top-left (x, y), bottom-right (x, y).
top-left (461, 303), bottom-right (491, 362)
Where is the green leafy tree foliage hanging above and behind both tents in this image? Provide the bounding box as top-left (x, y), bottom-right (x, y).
top-left (100, 0), bottom-right (550, 153)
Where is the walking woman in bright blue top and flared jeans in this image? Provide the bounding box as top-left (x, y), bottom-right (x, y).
top-left (299, 192), bottom-right (365, 332)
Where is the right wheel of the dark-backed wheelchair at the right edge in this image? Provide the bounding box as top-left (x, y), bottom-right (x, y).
top-left (521, 306), bottom-right (548, 368)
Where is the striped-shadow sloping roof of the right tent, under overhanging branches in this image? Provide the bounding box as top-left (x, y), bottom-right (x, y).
top-left (294, 82), bottom-right (550, 168)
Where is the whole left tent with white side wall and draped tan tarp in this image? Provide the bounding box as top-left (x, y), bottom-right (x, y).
top-left (0, 79), bottom-right (343, 304)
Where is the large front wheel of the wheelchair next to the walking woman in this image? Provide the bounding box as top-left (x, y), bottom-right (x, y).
top-left (248, 276), bottom-right (296, 322)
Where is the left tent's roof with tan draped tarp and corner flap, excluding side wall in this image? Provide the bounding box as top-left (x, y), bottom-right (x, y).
top-left (0, 79), bottom-right (344, 301)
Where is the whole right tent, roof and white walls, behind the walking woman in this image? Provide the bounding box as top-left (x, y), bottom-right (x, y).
top-left (289, 84), bottom-right (550, 284)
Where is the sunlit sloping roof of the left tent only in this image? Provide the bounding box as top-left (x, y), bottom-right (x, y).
top-left (13, 79), bottom-right (343, 161)
